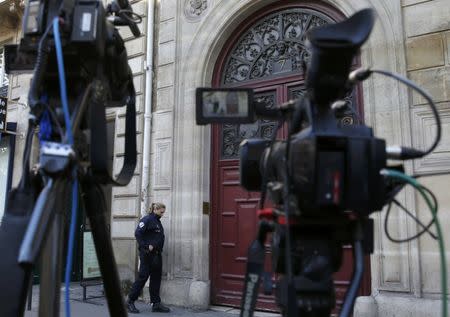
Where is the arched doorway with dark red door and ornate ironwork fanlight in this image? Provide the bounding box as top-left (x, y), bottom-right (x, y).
top-left (210, 1), bottom-right (370, 310)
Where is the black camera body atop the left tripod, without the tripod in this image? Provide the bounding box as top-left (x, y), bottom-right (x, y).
top-left (5, 0), bottom-right (139, 107)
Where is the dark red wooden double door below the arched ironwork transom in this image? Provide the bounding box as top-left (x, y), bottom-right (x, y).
top-left (211, 81), bottom-right (370, 310)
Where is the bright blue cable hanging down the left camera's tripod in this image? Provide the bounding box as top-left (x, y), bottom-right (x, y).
top-left (53, 17), bottom-right (78, 317)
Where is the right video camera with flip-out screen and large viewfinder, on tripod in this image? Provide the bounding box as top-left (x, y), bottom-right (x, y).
top-left (196, 9), bottom-right (440, 317)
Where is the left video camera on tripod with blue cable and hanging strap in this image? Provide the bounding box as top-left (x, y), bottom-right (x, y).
top-left (0, 0), bottom-right (142, 316)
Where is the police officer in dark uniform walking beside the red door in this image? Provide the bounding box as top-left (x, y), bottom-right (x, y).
top-left (127, 203), bottom-right (170, 314)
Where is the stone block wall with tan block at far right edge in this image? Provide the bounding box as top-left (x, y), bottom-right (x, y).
top-left (403, 0), bottom-right (450, 304)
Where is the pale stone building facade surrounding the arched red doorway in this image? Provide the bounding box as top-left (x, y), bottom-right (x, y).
top-left (0, 0), bottom-right (450, 317)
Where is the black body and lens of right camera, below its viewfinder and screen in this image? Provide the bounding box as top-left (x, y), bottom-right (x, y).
top-left (240, 115), bottom-right (386, 217)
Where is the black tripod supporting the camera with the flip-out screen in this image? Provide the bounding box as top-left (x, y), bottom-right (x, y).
top-left (240, 208), bottom-right (373, 317)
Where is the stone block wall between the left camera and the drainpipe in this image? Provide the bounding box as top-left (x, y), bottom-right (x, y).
top-left (107, 0), bottom-right (147, 281)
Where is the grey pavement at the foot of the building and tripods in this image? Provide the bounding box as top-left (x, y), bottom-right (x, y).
top-left (25, 283), bottom-right (280, 317)
